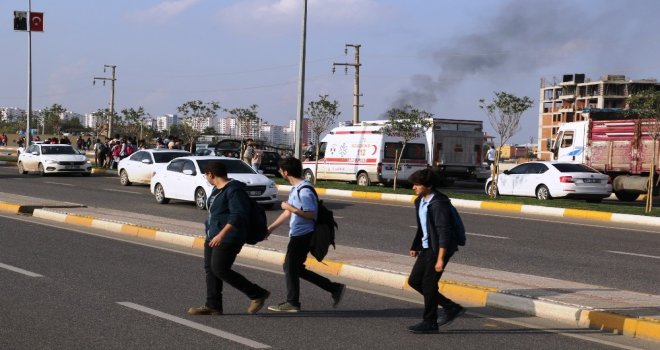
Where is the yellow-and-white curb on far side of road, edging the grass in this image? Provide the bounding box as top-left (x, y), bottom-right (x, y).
top-left (277, 185), bottom-right (660, 227)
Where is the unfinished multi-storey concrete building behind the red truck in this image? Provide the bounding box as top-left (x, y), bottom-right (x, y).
top-left (538, 74), bottom-right (660, 160)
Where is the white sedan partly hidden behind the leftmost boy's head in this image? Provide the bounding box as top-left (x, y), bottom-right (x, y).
top-left (150, 156), bottom-right (279, 209)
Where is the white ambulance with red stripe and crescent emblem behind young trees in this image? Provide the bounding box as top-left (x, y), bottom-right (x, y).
top-left (303, 120), bottom-right (428, 186)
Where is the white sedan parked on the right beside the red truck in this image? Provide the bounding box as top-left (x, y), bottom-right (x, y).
top-left (485, 161), bottom-right (612, 202)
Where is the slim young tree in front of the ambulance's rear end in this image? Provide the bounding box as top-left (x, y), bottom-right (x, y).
top-left (383, 105), bottom-right (433, 191)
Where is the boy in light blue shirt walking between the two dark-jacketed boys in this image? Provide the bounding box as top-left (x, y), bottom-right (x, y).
top-left (268, 157), bottom-right (346, 312)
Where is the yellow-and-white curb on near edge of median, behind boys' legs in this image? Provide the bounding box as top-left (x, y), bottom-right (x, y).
top-left (12, 203), bottom-right (660, 341)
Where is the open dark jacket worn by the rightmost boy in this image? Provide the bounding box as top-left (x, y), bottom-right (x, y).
top-left (410, 190), bottom-right (458, 254)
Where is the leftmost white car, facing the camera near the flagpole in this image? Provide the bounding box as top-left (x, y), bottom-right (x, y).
top-left (18, 144), bottom-right (92, 176)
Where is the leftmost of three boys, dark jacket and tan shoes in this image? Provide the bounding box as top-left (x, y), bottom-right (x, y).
top-left (188, 162), bottom-right (270, 315)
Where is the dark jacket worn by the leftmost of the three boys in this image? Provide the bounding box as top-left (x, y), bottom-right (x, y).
top-left (204, 180), bottom-right (251, 244)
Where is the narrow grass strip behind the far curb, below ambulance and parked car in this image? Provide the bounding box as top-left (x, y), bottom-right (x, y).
top-left (273, 178), bottom-right (660, 217)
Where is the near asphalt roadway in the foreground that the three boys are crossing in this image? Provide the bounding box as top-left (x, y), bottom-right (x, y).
top-left (0, 215), bottom-right (653, 349)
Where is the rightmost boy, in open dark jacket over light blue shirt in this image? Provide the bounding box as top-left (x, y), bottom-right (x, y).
top-left (408, 169), bottom-right (465, 333)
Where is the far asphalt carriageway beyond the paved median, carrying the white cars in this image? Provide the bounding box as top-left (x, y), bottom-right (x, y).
top-left (0, 167), bottom-right (660, 294)
